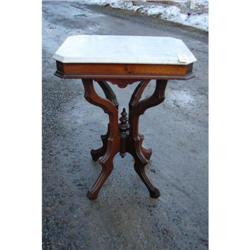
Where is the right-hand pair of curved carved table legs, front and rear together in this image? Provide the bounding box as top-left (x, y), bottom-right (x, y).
top-left (128, 80), bottom-right (167, 198)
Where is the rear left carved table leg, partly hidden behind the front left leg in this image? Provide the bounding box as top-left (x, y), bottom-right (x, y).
top-left (90, 81), bottom-right (119, 161)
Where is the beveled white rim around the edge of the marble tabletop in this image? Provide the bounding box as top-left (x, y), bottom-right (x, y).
top-left (53, 35), bottom-right (197, 65)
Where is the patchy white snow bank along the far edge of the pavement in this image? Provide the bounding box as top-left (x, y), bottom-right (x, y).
top-left (83, 0), bottom-right (208, 31)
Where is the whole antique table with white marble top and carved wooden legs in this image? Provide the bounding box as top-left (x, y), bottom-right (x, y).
top-left (53, 35), bottom-right (196, 199)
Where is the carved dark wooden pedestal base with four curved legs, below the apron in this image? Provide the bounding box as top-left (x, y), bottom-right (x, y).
top-left (82, 79), bottom-right (167, 200)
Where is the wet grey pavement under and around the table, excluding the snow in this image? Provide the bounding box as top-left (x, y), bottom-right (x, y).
top-left (43, 1), bottom-right (208, 250)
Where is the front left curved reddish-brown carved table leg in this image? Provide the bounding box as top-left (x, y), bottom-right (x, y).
top-left (82, 79), bottom-right (120, 200)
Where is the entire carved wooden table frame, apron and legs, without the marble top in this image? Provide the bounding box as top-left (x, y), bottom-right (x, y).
top-left (55, 61), bottom-right (193, 200)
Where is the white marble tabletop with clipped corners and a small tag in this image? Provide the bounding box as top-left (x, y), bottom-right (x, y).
top-left (53, 35), bottom-right (196, 65)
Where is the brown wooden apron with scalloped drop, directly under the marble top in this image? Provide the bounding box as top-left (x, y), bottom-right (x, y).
top-left (55, 61), bottom-right (194, 88)
